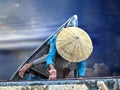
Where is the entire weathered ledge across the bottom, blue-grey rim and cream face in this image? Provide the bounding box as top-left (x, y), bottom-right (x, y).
top-left (0, 77), bottom-right (120, 90)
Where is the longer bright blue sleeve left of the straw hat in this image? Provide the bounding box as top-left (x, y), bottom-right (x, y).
top-left (46, 36), bottom-right (57, 67)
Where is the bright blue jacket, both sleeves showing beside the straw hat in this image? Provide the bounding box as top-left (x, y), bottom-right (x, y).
top-left (46, 35), bottom-right (86, 76)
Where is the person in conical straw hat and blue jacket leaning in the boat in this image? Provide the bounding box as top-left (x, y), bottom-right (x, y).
top-left (19, 27), bottom-right (93, 80)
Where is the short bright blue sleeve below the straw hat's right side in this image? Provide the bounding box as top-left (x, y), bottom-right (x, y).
top-left (77, 61), bottom-right (86, 77)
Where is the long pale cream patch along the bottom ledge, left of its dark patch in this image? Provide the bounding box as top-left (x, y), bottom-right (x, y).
top-left (0, 84), bottom-right (89, 90)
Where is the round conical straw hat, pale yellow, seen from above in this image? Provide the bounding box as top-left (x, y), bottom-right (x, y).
top-left (56, 27), bottom-right (93, 62)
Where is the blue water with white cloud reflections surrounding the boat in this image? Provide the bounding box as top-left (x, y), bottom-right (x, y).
top-left (0, 0), bottom-right (120, 80)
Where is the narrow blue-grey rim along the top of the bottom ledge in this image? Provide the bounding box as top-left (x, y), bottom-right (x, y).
top-left (0, 77), bottom-right (120, 86)
